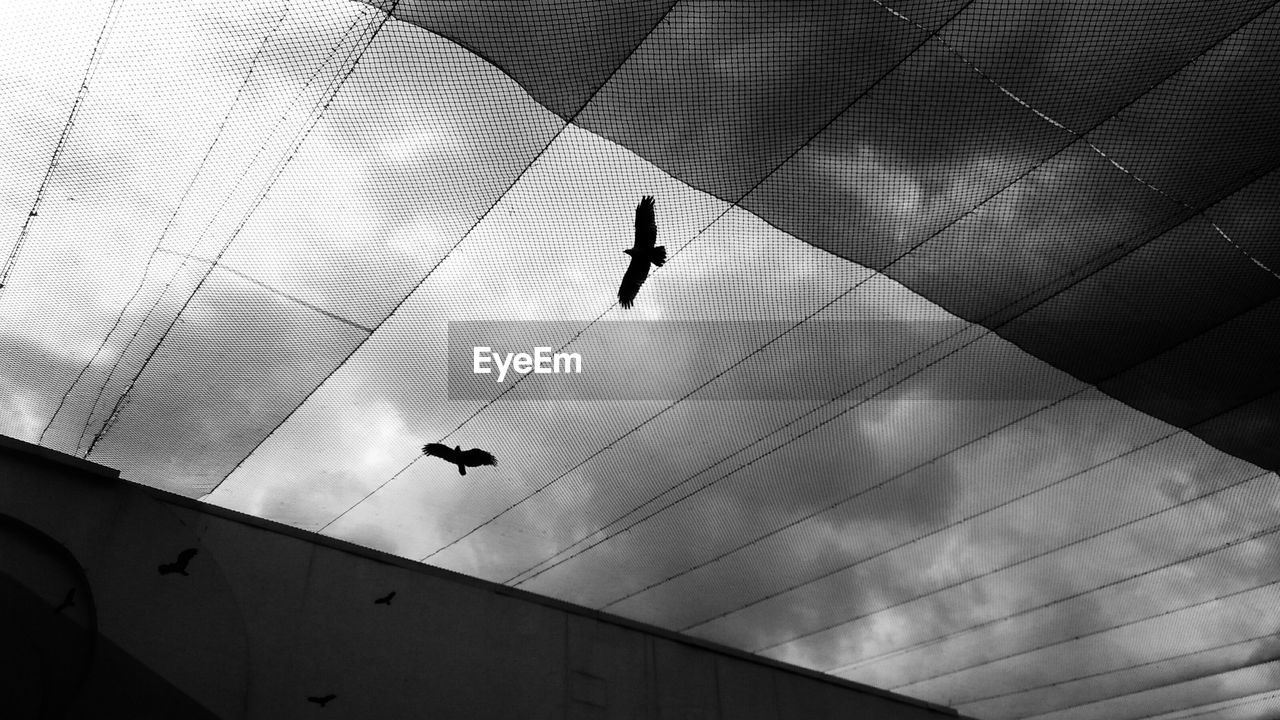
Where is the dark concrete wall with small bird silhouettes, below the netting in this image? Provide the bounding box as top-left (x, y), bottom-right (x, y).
top-left (0, 437), bottom-right (955, 720)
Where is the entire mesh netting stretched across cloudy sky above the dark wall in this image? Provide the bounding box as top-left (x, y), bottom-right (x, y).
top-left (0, 0), bottom-right (1280, 720)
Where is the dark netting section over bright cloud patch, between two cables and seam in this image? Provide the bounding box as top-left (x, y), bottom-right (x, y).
top-left (742, 30), bottom-right (1073, 269)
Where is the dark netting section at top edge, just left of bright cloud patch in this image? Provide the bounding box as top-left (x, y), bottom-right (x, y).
top-left (575, 1), bottom-right (952, 201)
